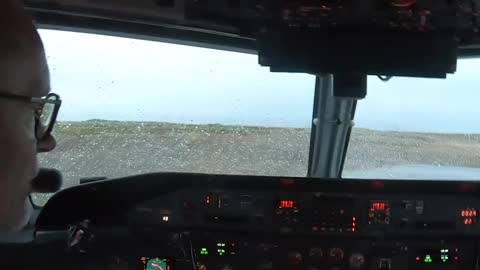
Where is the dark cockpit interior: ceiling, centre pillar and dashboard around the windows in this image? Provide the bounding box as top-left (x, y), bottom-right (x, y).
top-left (0, 0), bottom-right (480, 270)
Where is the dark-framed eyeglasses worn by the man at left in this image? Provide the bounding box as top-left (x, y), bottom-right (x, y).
top-left (0, 93), bottom-right (62, 140)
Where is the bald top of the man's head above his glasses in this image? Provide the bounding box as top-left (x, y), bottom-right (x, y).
top-left (0, 0), bottom-right (50, 97)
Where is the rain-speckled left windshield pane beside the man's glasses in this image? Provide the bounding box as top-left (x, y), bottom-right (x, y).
top-left (36, 30), bottom-right (315, 205)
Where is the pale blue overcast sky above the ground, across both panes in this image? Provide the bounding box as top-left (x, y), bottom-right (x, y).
top-left (40, 30), bottom-right (480, 133)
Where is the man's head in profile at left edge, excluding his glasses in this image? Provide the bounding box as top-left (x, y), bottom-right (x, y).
top-left (0, 0), bottom-right (55, 231)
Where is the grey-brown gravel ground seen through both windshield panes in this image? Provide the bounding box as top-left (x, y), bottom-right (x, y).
top-left (35, 121), bottom-right (480, 204)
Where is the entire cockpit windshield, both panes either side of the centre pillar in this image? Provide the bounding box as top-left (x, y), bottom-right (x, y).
top-left (34, 30), bottom-right (480, 204)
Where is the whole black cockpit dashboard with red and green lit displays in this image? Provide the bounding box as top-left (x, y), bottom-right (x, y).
top-left (37, 174), bottom-right (480, 270)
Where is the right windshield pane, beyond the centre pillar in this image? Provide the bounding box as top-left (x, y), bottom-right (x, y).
top-left (343, 59), bottom-right (480, 180)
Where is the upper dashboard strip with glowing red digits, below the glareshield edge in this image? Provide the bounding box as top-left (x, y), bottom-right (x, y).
top-left (130, 190), bottom-right (480, 236)
